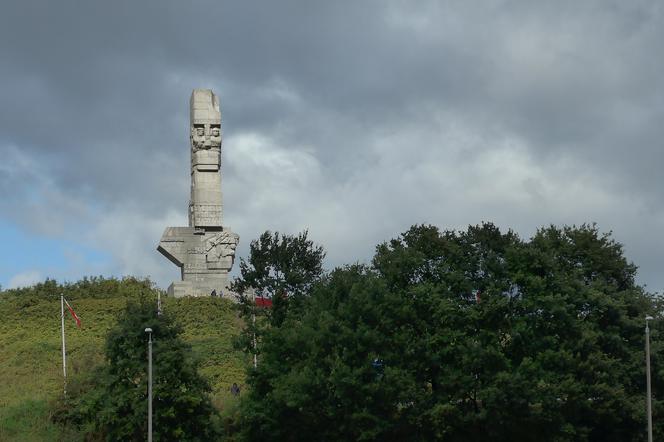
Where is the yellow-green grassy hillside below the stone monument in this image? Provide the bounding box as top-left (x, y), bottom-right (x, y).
top-left (0, 278), bottom-right (248, 441)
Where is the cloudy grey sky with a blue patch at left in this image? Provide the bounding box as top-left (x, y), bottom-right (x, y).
top-left (0, 0), bottom-right (664, 292)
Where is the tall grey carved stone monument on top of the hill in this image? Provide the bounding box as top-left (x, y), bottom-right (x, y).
top-left (157, 89), bottom-right (240, 297)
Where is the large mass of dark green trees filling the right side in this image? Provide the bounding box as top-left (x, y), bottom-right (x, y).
top-left (237, 224), bottom-right (664, 441)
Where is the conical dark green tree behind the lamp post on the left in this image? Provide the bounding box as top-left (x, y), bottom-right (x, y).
top-left (62, 297), bottom-right (218, 441)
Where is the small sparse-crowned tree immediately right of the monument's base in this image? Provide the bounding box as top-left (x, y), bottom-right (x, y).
top-left (232, 230), bottom-right (325, 360)
